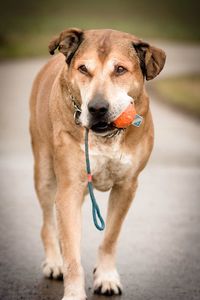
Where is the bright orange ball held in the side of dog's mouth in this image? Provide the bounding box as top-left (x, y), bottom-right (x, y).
top-left (113, 104), bottom-right (136, 128)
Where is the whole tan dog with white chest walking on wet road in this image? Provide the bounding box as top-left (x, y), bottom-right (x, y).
top-left (30, 28), bottom-right (165, 300)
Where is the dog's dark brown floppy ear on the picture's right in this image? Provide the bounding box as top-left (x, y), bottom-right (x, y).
top-left (133, 41), bottom-right (166, 80)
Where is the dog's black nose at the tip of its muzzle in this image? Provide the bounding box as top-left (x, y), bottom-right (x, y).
top-left (88, 97), bottom-right (109, 117)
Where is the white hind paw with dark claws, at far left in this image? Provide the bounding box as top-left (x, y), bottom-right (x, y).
top-left (42, 259), bottom-right (63, 280)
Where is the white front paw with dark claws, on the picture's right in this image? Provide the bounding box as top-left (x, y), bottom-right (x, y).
top-left (94, 268), bottom-right (122, 296)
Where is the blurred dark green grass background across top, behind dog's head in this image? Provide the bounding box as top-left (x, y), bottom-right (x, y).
top-left (0, 0), bottom-right (200, 58)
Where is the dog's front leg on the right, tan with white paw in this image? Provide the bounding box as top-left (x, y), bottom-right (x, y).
top-left (94, 179), bottom-right (137, 295)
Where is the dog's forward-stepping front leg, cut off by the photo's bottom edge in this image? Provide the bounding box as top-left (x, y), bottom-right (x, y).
top-left (56, 187), bottom-right (86, 300)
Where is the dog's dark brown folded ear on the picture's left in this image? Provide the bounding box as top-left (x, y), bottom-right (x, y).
top-left (49, 28), bottom-right (83, 64)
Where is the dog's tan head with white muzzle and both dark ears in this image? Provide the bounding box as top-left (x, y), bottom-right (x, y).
top-left (49, 28), bottom-right (165, 135)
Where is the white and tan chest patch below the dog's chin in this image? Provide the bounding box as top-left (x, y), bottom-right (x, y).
top-left (89, 139), bottom-right (132, 191)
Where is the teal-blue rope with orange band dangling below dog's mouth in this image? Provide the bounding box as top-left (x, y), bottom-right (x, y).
top-left (85, 128), bottom-right (105, 230)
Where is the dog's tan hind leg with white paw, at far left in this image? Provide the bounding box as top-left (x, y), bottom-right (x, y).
top-left (34, 147), bottom-right (62, 279)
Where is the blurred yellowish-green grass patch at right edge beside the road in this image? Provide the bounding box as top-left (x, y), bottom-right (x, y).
top-left (154, 74), bottom-right (200, 118)
